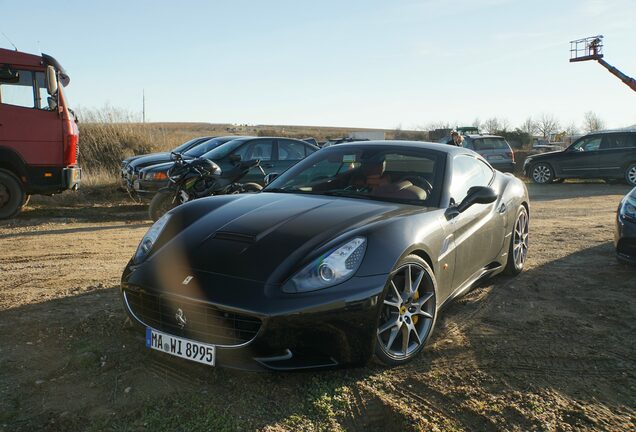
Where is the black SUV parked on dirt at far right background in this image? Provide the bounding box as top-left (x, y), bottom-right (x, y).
top-left (523, 129), bottom-right (636, 186)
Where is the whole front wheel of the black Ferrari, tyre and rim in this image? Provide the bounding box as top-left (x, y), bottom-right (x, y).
top-left (375, 255), bottom-right (437, 366)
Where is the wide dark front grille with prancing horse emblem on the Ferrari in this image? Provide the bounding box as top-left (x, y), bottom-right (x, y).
top-left (124, 290), bottom-right (261, 346)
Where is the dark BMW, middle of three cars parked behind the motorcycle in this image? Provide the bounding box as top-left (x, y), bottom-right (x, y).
top-left (129, 135), bottom-right (251, 198)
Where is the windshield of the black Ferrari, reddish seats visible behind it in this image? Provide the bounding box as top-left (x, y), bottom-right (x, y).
top-left (264, 145), bottom-right (443, 206)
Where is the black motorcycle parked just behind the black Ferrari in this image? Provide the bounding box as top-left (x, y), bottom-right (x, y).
top-left (148, 153), bottom-right (266, 221)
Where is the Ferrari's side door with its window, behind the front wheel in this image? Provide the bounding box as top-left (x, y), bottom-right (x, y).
top-left (448, 154), bottom-right (501, 289)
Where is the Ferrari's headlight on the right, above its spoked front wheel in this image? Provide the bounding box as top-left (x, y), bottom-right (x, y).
top-left (283, 237), bottom-right (367, 292)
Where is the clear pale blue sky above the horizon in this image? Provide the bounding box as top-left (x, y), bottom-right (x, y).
top-left (0, 0), bottom-right (636, 128)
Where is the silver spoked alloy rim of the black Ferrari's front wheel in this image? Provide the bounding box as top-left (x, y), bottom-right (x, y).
top-left (377, 264), bottom-right (436, 360)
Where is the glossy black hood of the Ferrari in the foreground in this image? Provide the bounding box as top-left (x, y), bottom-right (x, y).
top-left (153, 192), bottom-right (427, 283)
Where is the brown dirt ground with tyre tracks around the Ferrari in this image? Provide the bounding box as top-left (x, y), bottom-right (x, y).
top-left (0, 183), bottom-right (636, 432)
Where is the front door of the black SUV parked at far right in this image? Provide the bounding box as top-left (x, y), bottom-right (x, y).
top-left (555, 135), bottom-right (603, 177)
